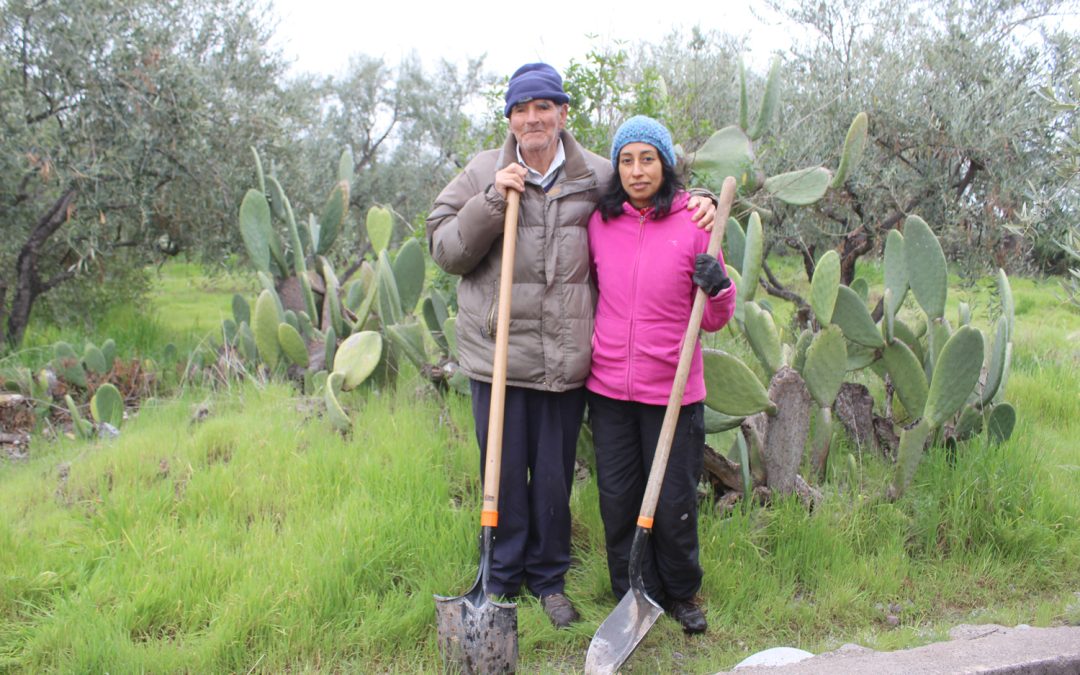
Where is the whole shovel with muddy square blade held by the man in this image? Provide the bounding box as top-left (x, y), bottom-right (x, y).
top-left (435, 190), bottom-right (521, 674)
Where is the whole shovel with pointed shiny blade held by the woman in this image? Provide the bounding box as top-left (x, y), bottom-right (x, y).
top-left (585, 177), bottom-right (735, 675)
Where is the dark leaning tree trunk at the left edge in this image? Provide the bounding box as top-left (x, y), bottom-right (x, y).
top-left (4, 186), bottom-right (79, 349)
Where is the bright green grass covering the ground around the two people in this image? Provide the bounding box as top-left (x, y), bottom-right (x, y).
top-left (0, 263), bottom-right (1080, 673)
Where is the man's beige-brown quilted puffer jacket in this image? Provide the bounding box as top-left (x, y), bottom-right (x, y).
top-left (428, 131), bottom-right (613, 391)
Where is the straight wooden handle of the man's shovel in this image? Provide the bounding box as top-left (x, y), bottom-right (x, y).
top-left (480, 189), bottom-right (522, 527)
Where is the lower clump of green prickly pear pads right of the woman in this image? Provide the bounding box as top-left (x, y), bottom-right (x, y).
top-left (704, 211), bottom-right (1014, 499)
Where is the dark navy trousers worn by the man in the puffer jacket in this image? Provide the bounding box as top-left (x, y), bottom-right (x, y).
top-left (472, 380), bottom-right (585, 597)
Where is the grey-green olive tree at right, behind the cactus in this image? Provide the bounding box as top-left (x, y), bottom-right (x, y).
top-left (762, 0), bottom-right (1080, 281)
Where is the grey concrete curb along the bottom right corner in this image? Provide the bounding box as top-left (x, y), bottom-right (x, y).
top-left (717, 624), bottom-right (1080, 675)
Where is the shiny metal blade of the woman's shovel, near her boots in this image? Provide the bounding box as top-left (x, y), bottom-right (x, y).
top-left (585, 586), bottom-right (664, 675)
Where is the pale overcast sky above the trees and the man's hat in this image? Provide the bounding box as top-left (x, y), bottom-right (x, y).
top-left (273, 0), bottom-right (787, 76)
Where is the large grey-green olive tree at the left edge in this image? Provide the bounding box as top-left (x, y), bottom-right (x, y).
top-left (0, 0), bottom-right (283, 346)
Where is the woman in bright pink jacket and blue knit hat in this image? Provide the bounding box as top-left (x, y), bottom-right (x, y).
top-left (585, 116), bottom-right (735, 633)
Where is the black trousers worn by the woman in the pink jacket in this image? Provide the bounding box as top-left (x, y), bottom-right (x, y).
top-left (589, 392), bottom-right (705, 603)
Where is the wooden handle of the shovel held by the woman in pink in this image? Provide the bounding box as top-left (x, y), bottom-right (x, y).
top-left (637, 176), bottom-right (735, 529)
